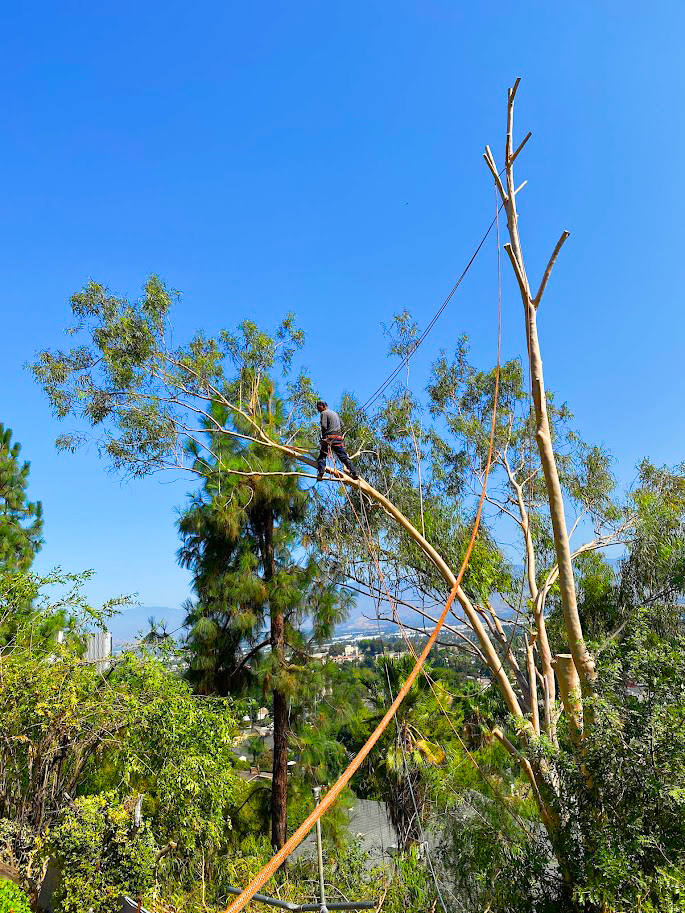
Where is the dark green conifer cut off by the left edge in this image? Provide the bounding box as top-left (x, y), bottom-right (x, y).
top-left (0, 423), bottom-right (43, 571)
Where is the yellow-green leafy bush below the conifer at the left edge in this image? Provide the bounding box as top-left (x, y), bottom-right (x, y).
top-left (0, 575), bottom-right (243, 891)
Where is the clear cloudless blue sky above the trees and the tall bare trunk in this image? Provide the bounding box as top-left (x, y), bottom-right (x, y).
top-left (0, 0), bottom-right (685, 606)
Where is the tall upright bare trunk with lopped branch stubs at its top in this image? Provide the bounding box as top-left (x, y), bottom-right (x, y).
top-left (485, 79), bottom-right (596, 693)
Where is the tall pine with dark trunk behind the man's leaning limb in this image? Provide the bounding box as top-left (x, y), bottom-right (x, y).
top-left (179, 396), bottom-right (345, 848)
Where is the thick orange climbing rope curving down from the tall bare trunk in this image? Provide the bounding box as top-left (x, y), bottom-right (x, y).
top-left (224, 214), bottom-right (502, 913)
